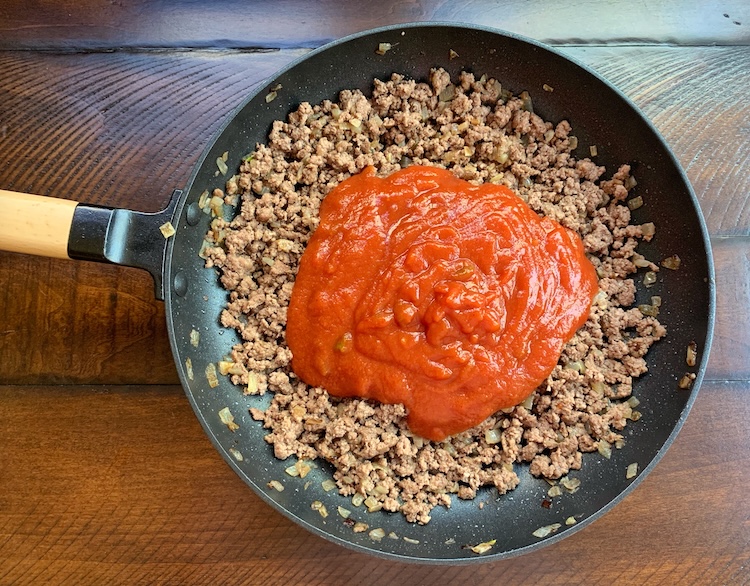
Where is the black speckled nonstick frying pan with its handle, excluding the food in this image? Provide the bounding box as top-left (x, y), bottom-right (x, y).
top-left (0, 23), bottom-right (715, 564)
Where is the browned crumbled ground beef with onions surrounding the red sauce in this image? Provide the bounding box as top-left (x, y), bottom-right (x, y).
top-left (202, 69), bottom-right (665, 523)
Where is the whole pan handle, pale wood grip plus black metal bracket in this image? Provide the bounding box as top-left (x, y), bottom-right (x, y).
top-left (0, 189), bottom-right (182, 300)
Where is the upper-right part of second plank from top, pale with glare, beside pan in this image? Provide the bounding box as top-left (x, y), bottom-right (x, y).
top-left (562, 47), bottom-right (750, 236)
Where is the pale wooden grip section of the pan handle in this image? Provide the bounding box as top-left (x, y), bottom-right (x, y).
top-left (0, 189), bottom-right (78, 258)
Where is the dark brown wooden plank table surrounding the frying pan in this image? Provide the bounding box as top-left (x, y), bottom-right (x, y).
top-left (0, 0), bottom-right (750, 585)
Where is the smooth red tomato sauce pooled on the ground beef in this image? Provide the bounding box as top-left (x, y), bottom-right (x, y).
top-left (286, 166), bottom-right (597, 441)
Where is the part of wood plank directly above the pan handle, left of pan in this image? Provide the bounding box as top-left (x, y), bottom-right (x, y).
top-left (0, 51), bottom-right (305, 211)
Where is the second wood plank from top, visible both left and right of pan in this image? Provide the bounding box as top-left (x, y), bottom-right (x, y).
top-left (0, 47), bottom-right (750, 229)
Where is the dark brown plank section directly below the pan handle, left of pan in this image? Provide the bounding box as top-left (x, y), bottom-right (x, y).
top-left (0, 253), bottom-right (173, 384)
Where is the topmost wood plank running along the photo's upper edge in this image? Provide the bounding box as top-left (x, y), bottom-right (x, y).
top-left (0, 0), bottom-right (750, 50)
